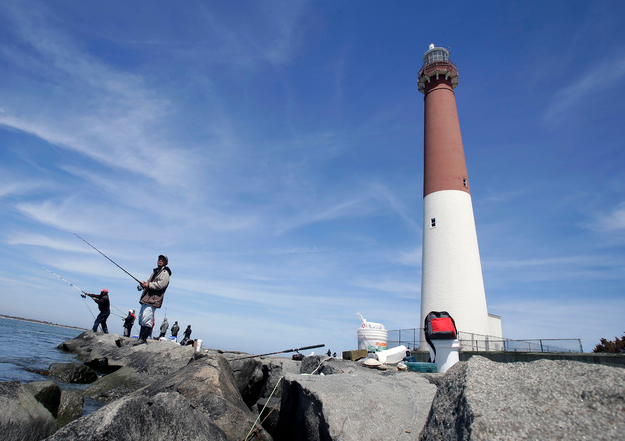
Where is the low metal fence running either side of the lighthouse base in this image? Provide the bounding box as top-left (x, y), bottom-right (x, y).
top-left (387, 328), bottom-right (584, 353)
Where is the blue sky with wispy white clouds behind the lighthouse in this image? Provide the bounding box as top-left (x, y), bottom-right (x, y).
top-left (0, 0), bottom-right (625, 353)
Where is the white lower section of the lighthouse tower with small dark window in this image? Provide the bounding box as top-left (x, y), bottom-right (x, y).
top-left (421, 190), bottom-right (491, 348)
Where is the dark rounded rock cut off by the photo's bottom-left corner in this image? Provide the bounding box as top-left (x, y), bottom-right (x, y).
top-left (0, 381), bottom-right (56, 441)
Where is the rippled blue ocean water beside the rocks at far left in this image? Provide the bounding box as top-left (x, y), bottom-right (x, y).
top-left (0, 317), bottom-right (83, 383)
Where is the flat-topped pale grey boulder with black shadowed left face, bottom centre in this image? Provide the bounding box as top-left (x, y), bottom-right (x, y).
top-left (275, 367), bottom-right (436, 441)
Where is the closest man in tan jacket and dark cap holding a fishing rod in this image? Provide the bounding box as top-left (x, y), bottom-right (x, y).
top-left (135, 254), bottom-right (171, 345)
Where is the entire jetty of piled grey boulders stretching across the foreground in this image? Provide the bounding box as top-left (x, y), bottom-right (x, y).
top-left (0, 331), bottom-right (625, 441)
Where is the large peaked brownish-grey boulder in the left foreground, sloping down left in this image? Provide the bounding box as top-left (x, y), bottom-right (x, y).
top-left (50, 355), bottom-right (271, 441)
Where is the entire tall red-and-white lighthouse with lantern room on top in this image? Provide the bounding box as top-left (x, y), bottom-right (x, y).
top-left (418, 44), bottom-right (501, 349)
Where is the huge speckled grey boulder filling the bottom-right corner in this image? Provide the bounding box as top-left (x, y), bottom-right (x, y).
top-left (421, 356), bottom-right (625, 440)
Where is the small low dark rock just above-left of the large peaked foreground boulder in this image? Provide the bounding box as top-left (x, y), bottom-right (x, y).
top-left (84, 366), bottom-right (153, 402)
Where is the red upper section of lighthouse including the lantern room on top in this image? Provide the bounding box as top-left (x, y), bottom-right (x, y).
top-left (418, 46), bottom-right (470, 197)
